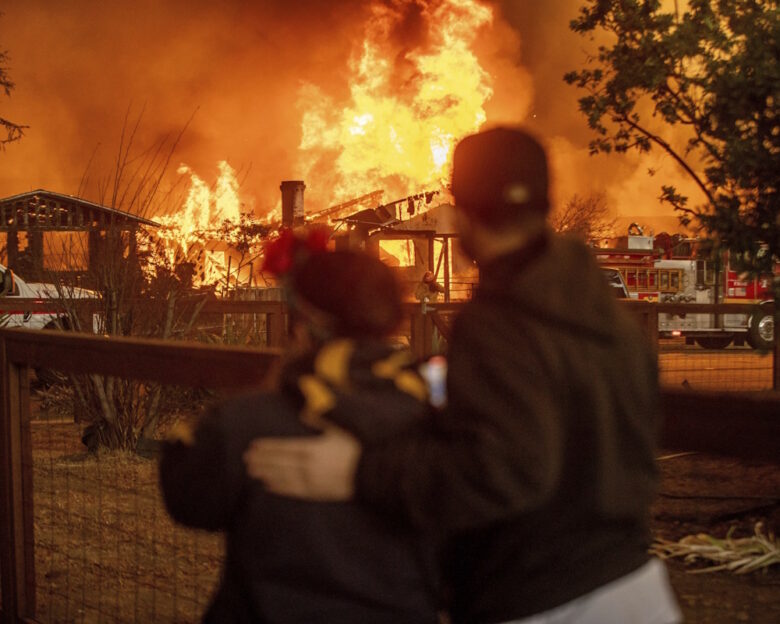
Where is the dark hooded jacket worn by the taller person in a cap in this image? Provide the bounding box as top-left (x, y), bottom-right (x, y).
top-left (350, 234), bottom-right (658, 622)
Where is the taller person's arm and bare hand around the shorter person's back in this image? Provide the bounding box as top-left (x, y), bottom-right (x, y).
top-left (244, 304), bottom-right (563, 531)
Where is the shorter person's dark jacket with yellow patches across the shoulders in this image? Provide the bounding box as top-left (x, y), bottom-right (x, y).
top-left (160, 340), bottom-right (437, 624)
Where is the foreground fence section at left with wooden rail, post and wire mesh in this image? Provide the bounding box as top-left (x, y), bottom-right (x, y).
top-left (0, 324), bottom-right (280, 623)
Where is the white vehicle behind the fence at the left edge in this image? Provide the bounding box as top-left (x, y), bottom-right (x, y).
top-left (0, 264), bottom-right (97, 329)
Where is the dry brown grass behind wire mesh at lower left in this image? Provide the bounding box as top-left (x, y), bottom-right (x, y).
top-left (32, 421), bottom-right (223, 623)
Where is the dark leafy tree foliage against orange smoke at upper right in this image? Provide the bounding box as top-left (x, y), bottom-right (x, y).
top-left (564, 0), bottom-right (780, 273)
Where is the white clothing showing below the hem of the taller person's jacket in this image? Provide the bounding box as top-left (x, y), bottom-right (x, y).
top-left (504, 559), bottom-right (682, 624)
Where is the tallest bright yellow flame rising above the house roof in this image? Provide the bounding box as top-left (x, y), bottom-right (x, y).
top-left (300, 0), bottom-right (493, 207)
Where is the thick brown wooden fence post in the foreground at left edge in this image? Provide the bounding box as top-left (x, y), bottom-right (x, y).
top-left (0, 340), bottom-right (35, 622)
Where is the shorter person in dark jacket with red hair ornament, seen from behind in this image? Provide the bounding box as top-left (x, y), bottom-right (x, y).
top-left (160, 231), bottom-right (438, 624)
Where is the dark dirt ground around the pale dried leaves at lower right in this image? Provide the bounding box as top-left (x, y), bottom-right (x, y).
top-left (653, 454), bottom-right (780, 624)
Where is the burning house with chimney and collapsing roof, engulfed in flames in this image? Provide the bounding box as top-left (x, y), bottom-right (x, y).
top-left (36, 0), bottom-right (506, 299)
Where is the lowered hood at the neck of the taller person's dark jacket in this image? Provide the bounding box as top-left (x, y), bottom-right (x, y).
top-left (481, 234), bottom-right (619, 339)
